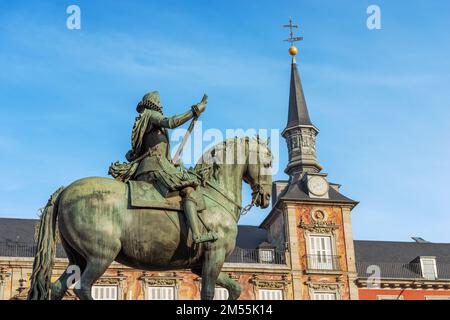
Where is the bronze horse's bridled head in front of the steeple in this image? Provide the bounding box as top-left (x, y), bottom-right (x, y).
top-left (243, 138), bottom-right (272, 208)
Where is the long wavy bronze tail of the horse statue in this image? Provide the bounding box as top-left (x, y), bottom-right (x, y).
top-left (28, 187), bottom-right (64, 300)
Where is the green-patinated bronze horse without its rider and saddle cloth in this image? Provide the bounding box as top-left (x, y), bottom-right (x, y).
top-left (28, 137), bottom-right (272, 300)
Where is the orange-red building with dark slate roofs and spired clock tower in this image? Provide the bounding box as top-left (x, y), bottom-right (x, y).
top-left (0, 50), bottom-right (450, 300)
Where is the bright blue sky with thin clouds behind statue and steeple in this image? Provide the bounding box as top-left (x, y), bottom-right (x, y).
top-left (0, 0), bottom-right (450, 242)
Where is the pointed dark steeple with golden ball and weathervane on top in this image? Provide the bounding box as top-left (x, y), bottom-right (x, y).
top-left (282, 19), bottom-right (322, 181)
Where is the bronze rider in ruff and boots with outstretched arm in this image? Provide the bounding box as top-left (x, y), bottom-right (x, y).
top-left (126, 91), bottom-right (217, 243)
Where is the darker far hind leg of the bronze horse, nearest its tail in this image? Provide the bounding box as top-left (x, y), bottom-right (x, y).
top-left (51, 234), bottom-right (86, 300)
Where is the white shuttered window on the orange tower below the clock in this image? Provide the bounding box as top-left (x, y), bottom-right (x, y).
top-left (308, 236), bottom-right (333, 270)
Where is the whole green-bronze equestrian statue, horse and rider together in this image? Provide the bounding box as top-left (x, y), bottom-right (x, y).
top-left (28, 92), bottom-right (272, 300)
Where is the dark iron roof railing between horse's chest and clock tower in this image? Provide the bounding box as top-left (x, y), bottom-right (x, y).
top-left (226, 247), bottom-right (286, 265)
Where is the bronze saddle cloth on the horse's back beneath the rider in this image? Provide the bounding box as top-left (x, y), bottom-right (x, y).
top-left (127, 180), bottom-right (206, 211)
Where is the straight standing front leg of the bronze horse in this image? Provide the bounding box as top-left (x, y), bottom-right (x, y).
top-left (201, 246), bottom-right (225, 300)
